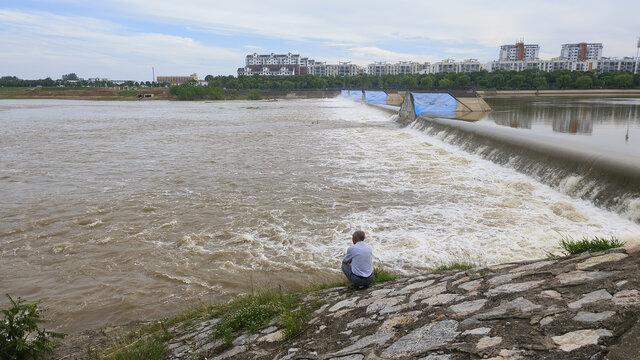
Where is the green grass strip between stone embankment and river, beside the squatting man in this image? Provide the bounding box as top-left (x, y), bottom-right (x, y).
top-left (89, 267), bottom-right (397, 360)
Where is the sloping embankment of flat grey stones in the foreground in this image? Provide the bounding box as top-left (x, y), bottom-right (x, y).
top-left (167, 247), bottom-right (640, 360)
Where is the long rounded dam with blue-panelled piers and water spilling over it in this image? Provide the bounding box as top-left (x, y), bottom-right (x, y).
top-left (342, 90), bottom-right (640, 223)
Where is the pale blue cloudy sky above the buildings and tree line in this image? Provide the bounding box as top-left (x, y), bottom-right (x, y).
top-left (0, 0), bottom-right (640, 81)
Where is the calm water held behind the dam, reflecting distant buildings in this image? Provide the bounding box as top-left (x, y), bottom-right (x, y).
top-left (481, 97), bottom-right (640, 157)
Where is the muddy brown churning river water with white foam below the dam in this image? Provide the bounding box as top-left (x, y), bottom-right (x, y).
top-left (0, 98), bottom-right (640, 332)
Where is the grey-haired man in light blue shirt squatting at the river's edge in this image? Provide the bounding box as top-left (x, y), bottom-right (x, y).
top-left (342, 230), bottom-right (373, 289)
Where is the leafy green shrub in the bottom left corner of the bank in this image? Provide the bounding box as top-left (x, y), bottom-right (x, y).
top-left (0, 294), bottom-right (65, 360)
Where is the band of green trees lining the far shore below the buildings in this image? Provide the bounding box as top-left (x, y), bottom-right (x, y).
top-left (0, 69), bottom-right (640, 100)
